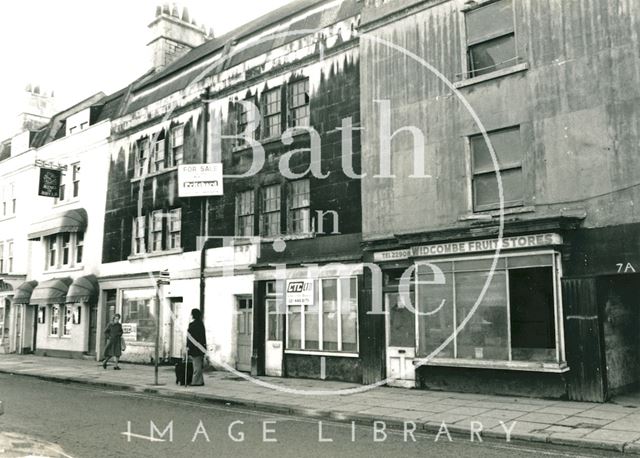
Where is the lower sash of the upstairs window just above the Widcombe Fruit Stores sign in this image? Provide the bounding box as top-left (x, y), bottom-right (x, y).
top-left (473, 168), bottom-right (523, 210)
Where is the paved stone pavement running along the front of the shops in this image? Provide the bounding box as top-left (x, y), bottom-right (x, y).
top-left (0, 355), bottom-right (640, 455)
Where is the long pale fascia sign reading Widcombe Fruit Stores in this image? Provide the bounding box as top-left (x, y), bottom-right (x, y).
top-left (373, 233), bottom-right (562, 262)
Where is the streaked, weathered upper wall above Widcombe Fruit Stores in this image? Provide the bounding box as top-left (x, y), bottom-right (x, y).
top-left (361, 0), bottom-right (640, 239)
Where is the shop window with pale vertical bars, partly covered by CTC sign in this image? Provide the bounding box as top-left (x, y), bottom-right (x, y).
top-left (287, 277), bottom-right (358, 352)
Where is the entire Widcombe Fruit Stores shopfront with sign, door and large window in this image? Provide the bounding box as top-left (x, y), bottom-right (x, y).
top-left (374, 233), bottom-right (569, 398)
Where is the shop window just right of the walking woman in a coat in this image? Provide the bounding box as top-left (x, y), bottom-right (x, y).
top-left (122, 289), bottom-right (156, 342)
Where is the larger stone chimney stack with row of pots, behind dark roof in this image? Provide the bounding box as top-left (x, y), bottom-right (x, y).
top-left (147, 3), bottom-right (213, 71)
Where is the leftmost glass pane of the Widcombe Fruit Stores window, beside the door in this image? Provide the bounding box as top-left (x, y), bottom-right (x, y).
top-left (412, 262), bottom-right (454, 358)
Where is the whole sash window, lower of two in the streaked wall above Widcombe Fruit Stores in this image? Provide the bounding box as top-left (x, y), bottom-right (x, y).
top-left (469, 127), bottom-right (524, 211)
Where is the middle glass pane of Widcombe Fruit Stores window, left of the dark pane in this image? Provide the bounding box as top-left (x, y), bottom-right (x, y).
top-left (455, 270), bottom-right (509, 361)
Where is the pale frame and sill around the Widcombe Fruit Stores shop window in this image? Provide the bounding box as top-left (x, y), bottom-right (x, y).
top-left (410, 250), bottom-right (568, 372)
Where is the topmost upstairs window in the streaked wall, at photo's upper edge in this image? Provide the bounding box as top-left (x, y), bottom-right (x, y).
top-left (466, 0), bottom-right (518, 77)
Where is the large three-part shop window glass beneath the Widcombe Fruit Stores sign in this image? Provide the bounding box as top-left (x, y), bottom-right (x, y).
top-left (415, 253), bottom-right (561, 363)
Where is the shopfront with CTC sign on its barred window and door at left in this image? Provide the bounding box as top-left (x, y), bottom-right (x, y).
top-left (254, 264), bottom-right (362, 383)
